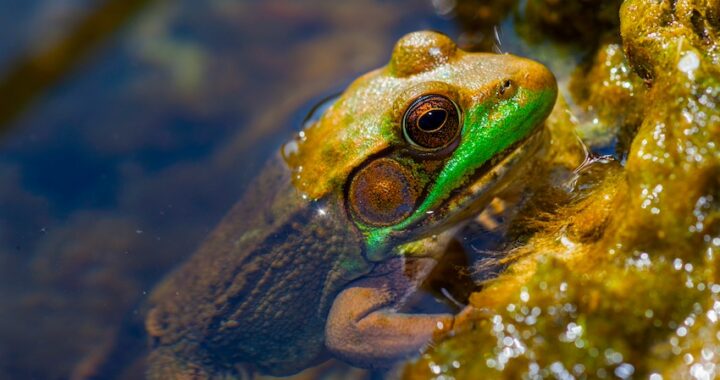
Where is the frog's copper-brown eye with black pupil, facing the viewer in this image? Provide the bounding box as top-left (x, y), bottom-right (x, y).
top-left (403, 95), bottom-right (460, 150)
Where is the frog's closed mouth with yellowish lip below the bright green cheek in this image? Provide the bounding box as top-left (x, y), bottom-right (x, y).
top-left (421, 128), bottom-right (547, 236)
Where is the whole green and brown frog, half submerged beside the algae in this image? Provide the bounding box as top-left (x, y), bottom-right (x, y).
top-left (146, 32), bottom-right (557, 379)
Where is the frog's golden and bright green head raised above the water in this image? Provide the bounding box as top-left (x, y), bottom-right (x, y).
top-left (286, 32), bottom-right (557, 261)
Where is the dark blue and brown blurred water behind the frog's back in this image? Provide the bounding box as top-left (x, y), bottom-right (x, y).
top-left (0, 0), bottom-right (620, 379)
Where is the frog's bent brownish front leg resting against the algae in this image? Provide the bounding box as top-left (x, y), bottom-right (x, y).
top-left (325, 257), bottom-right (454, 367)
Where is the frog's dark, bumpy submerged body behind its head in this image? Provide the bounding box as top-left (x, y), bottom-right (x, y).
top-left (146, 154), bottom-right (368, 378)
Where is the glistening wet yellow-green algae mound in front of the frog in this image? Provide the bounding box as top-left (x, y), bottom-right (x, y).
top-left (404, 0), bottom-right (720, 379)
